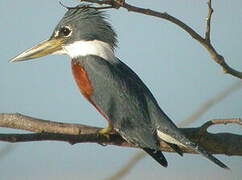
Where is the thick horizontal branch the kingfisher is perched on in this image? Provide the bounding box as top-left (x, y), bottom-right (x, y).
top-left (0, 114), bottom-right (242, 156)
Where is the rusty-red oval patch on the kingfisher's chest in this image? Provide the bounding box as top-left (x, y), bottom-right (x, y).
top-left (71, 62), bottom-right (93, 99)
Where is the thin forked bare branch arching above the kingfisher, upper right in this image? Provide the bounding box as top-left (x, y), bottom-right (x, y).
top-left (79, 0), bottom-right (242, 79)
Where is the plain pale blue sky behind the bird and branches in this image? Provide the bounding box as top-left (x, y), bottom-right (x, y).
top-left (0, 0), bottom-right (242, 180)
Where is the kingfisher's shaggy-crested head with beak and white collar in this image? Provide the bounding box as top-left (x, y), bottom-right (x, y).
top-left (10, 6), bottom-right (117, 62)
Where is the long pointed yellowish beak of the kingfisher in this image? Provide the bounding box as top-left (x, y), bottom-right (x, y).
top-left (10, 38), bottom-right (64, 62)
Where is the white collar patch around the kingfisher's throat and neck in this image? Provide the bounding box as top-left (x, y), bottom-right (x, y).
top-left (62, 40), bottom-right (115, 60)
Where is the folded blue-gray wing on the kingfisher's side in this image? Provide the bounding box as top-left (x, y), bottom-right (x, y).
top-left (78, 56), bottom-right (159, 150)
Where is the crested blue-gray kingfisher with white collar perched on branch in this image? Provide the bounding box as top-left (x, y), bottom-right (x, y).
top-left (10, 5), bottom-right (229, 169)
